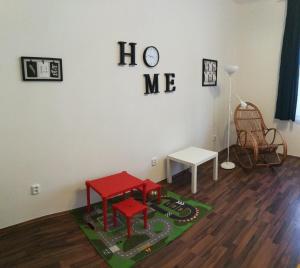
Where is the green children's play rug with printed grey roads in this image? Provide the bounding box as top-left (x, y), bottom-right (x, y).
top-left (72, 189), bottom-right (212, 268)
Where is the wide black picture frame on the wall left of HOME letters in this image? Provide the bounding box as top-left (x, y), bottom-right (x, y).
top-left (21, 57), bottom-right (63, 81)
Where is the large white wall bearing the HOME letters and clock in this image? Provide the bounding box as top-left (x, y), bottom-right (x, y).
top-left (0, 0), bottom-right (237, 228)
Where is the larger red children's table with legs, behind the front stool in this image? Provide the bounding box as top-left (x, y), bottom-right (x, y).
top-left (85, 171), bottom-right (146, 231)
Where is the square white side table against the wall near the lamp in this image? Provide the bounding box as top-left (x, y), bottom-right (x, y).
top-left (167, 147), bottom-right (218, 194)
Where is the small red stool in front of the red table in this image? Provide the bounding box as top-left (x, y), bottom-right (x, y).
top-left (112, 198), bottom-right (147, 238)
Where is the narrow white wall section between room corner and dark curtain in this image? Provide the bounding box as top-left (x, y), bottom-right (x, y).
top-left (237, 0), bottom-right (300, 156)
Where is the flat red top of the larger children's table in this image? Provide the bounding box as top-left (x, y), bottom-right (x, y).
top-left (86, 171), bottom-right (144, 198)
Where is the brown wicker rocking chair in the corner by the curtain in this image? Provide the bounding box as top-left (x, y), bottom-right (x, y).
top-left (234, 102), bottom-right (287, 168)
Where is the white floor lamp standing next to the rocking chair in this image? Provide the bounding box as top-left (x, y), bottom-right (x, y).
top-left (221, 65), bottom-right (239, 169)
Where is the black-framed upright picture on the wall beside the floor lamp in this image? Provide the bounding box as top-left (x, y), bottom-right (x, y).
top-left (202, 59), bottom-right (218, 87)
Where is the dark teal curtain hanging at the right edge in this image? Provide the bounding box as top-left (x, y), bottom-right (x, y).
top-left (275, 0), bottom-right (300, 121)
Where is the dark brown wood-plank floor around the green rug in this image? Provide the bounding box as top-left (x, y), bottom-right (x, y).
top-left (0, 152), bottom-right (300, 268)
